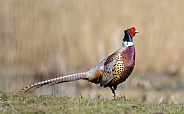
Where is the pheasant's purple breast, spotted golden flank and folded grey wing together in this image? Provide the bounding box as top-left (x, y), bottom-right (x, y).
top-left (100, 47), bottom-right (135, 87)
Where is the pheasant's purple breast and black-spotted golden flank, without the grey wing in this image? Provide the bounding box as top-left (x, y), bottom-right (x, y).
top-left (104, 46), bottom-right (135, 88)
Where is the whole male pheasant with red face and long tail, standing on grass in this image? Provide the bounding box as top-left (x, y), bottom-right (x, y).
top-left (19, 27), bottom-right (138, 98)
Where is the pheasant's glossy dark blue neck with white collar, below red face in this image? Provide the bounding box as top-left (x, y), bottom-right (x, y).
top-left (122, 33), bottom-right (134, 47)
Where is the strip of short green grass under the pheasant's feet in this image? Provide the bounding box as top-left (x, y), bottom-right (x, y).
top-left (0, 92), bottom-right (184, 114)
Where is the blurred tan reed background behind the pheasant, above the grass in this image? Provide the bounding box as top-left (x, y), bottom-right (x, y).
top-left (0, 0), bottom-right (184, 103)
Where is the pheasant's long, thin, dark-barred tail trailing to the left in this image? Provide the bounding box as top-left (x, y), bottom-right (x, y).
top-left (19, 72), bottom-right (88, 92)
